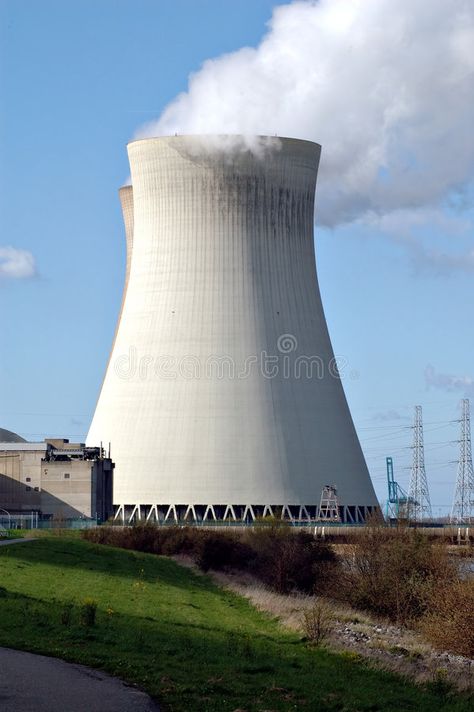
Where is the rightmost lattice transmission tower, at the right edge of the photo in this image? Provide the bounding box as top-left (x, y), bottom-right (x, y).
top-left (450, 398), bottom-right (474, 524)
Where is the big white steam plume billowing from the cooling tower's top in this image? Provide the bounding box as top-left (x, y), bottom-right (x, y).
top-left (136, 0), bottom-right (474, 227)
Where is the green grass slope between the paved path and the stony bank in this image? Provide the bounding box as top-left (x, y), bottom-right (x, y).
top-left (0, 537), bottom-right (472, 712)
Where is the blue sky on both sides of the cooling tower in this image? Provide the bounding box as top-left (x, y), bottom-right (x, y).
top-left (0, 0), bottom-right (474, 514)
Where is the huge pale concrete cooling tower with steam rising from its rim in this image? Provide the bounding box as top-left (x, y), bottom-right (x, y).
top-left (88, 136), bottom-right (377, 522)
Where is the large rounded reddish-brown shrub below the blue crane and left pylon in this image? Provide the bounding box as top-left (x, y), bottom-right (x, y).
top-left (332, 526), bottom-right (455, 623)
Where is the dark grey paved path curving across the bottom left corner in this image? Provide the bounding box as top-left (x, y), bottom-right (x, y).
top-left (0, 648), bottom-right (159, 712)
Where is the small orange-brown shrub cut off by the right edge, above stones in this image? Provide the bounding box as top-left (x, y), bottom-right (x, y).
top-left (420, 579), bottom-right (474, 658)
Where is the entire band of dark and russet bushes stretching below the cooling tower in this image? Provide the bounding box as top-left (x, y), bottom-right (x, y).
top-left (83, 521), bottom-right (474, 657)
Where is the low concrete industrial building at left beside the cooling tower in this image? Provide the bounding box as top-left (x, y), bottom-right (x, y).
top-left (0, 430), bottom-right (114, 521)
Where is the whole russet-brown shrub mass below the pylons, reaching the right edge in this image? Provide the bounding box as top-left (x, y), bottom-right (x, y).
top-left (331, 526), bottom-right (474, 657)
